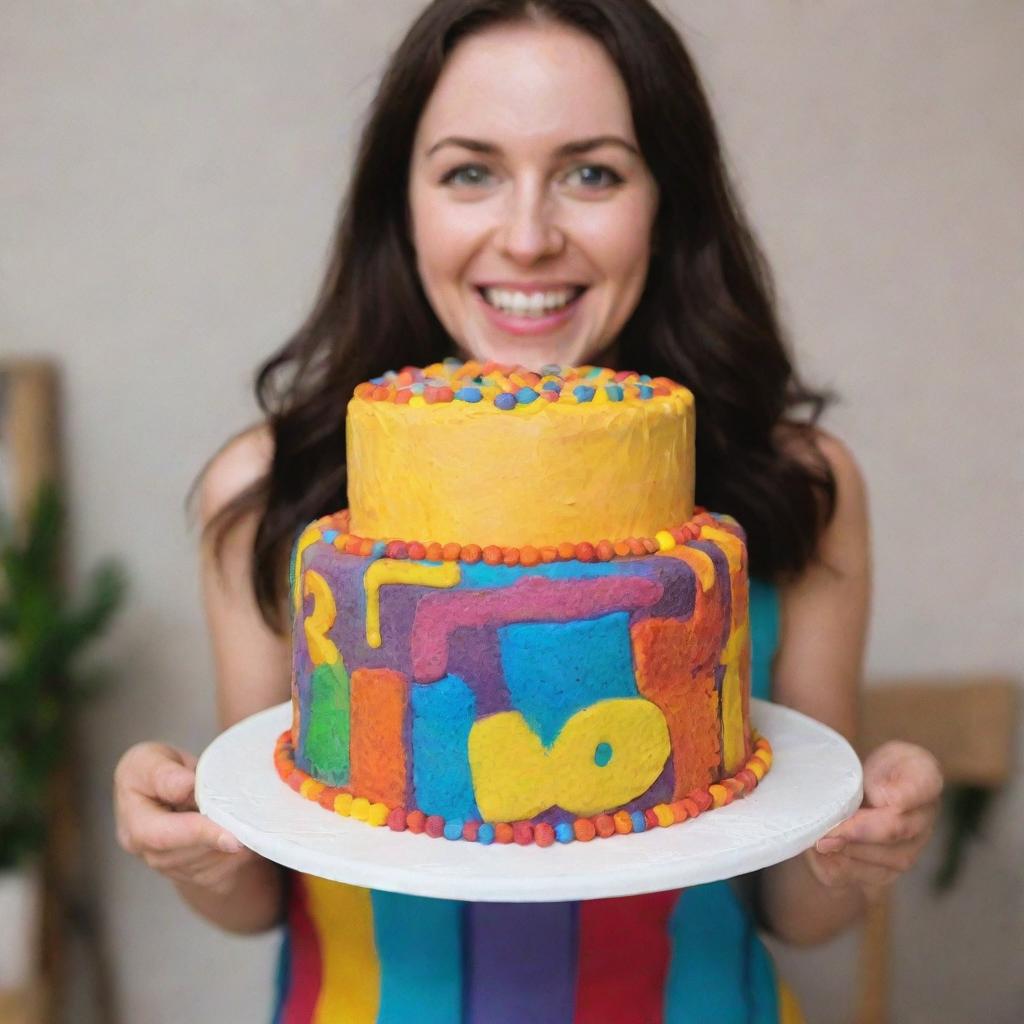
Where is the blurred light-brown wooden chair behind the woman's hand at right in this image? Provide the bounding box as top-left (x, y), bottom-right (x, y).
top-left (855, 677), bottom-right (1017, 1024)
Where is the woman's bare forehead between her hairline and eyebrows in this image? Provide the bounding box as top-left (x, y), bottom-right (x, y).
top-left (417, 23), bottom-right (633, 151)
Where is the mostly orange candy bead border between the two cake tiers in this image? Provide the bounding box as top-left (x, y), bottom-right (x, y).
top-left (308, 508), bottom-right (743, 566)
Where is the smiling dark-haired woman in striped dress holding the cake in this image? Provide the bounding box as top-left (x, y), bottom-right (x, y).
top-left (116, 0), bottom-right (941, 1022)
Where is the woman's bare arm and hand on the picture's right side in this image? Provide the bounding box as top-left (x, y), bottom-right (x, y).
top-left (759, 434), bottom-right (941, 945)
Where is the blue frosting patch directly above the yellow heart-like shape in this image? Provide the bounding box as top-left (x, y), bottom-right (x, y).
top-left (497, 611), bottom-right (637, 749)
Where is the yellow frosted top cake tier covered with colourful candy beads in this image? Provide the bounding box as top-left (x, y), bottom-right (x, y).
top-left (347, 360), bottom-right (694, 547)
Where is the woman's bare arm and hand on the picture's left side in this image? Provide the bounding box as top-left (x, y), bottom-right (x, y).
top-left (115, 419), bottom-right (290, 932)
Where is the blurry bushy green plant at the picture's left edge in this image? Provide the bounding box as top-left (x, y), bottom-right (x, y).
top-left (0, 484), bottom-right (125, 867)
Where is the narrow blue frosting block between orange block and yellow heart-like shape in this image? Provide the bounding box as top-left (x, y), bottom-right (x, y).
top-left (412, 676), bottom-right (480, 819)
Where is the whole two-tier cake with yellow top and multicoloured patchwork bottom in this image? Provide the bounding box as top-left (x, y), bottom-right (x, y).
top-left (274, 361), bottom-right (771, 846)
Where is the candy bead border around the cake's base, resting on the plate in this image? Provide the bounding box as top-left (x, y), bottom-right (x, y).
top-left (273, 729), bottom-right (772, 847)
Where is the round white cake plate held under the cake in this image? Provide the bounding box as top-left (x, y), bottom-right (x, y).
top-left (196, 700), bottom-right (862, 903)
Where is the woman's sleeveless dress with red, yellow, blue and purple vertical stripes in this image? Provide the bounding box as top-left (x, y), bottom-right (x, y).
top-left (272, 581), bottom-right (803, 1024)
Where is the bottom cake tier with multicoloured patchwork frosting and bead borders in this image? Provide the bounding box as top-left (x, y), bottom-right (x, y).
top-left (274, 513), bottom-right (771, 846)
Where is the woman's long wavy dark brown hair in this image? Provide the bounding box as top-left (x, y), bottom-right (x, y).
top-left (199, 0), bottom-right (836, 630)
